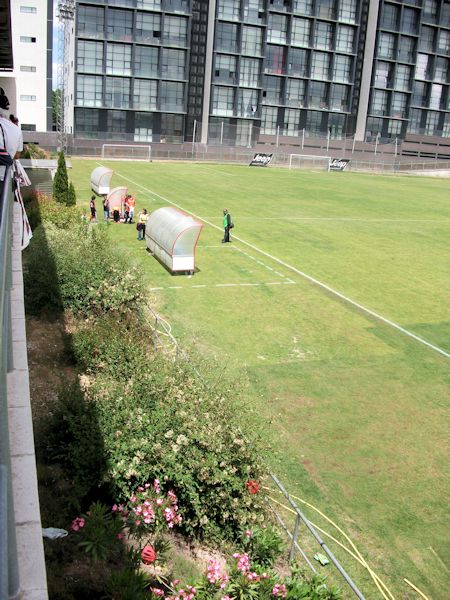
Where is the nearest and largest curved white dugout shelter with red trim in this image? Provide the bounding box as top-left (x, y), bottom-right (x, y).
top-left (145, 206), bottom-right (203, 273)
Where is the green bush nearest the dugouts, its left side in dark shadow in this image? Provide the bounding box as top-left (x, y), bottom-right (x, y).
top-left (24, 221), bottom-right (143, 316)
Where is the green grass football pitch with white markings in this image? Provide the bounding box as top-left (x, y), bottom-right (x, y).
top-left (69, 159), bottom-right (450, 598)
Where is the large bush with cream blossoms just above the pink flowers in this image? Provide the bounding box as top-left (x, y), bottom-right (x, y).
top-left (88, 358), bottom-right (264, 540)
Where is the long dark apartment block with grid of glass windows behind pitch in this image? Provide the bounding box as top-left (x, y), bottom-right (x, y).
top-left (68, 0), bottom-right (450, 146)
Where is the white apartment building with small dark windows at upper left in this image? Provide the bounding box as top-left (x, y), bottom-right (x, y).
top-left (0, 0), bottom-right (53, 131)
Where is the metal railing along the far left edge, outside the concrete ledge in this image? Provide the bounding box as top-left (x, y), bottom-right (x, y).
top-left (0, 167), bottom-right (19, 600)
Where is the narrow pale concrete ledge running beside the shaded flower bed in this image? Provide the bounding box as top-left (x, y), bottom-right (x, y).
top-left (7, 203), bottom-right (48, 600)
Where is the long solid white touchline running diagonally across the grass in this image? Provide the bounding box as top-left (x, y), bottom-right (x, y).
top-left (112, 172), bottom-right (450, 358)
